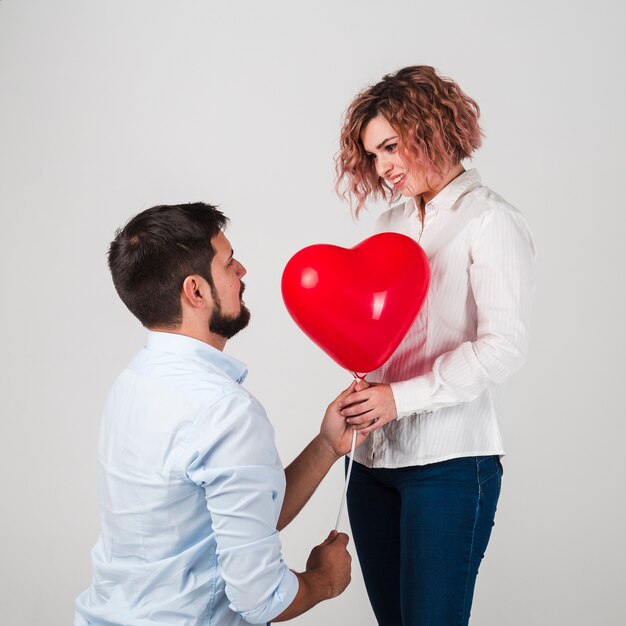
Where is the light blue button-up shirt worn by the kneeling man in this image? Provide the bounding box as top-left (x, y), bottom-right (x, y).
top-left (75, 332), bottom-right (298, 626)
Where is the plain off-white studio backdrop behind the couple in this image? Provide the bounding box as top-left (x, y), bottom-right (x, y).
top-left (0, 0), bottom-right (626, 626)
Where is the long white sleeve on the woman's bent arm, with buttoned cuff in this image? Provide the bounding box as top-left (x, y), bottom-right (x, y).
top-left (391, 210), bottom-right (535, 418)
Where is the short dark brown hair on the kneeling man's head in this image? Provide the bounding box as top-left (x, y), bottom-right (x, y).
top-left (109, 202), bottom-right (228, 327)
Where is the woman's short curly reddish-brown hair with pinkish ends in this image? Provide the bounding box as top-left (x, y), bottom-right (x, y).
top-left (335, 65), bottom-right (482, 216)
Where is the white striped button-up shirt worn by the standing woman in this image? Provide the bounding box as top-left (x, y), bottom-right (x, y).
top-left (354, 170), bottom-right (535, 468)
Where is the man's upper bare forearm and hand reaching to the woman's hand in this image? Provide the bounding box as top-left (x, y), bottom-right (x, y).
top-left (276, 381), bottom-right (368, 530)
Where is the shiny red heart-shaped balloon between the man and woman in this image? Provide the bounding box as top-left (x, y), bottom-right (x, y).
top-left (282, 233), bottom-right (430, 374)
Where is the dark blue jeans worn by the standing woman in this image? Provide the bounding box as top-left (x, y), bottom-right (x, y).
top-left (348, 456), bottom-right (502, 626)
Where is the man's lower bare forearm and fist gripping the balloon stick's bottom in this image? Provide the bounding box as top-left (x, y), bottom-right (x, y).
top-left (272, 530), bottom-right (352, 622)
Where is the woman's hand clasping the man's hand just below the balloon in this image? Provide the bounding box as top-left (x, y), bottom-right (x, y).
top-left (339, 383), bottom-right (398, 435)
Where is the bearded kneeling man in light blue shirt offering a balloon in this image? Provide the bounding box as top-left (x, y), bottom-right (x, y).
top-left (75, 203), bottom-right (364, 626)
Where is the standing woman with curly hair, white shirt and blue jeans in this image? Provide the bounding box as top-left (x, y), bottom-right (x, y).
top-left (337, 66), bottom-right (534, 626)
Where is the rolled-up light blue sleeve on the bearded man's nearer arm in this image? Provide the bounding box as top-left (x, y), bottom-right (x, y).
top-left (187, 392), bottom-right (298, 624)
